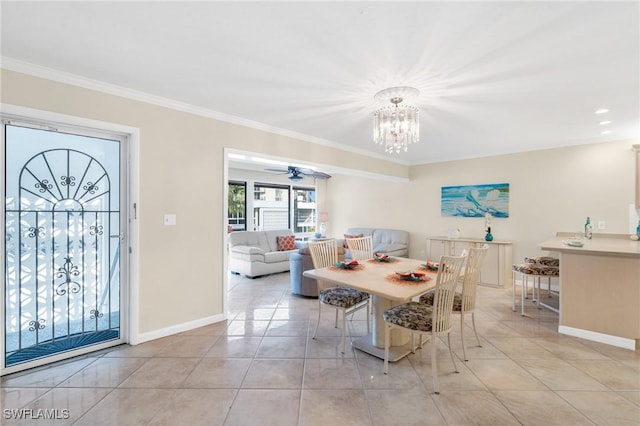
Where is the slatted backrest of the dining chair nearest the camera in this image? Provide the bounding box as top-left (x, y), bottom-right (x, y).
top-left (431, 256), bottom-right (467, 333)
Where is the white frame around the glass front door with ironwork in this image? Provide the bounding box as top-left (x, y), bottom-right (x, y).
top-left (0, 103), bottom-right (140, 376)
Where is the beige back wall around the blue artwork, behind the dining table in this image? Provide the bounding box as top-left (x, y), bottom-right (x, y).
top-left (327, 140), bottom-right (634, 261)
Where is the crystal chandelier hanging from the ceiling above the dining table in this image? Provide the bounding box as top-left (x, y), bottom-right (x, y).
top-left (373, 87), bottom-right (420, 154)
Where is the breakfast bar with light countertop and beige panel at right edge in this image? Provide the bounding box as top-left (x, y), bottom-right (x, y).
top-left (538, 235), bottom-right (640, 351)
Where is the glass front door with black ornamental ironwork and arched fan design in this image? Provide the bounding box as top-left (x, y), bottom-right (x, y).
top-left (3, 121), bottom-right (126, 371)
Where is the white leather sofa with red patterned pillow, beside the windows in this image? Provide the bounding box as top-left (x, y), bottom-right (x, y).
top-left (228, 229), bottom-right (300, 278)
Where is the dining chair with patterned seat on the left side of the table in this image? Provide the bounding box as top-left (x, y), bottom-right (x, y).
top-left (309, 238), bottom-right (370, 353)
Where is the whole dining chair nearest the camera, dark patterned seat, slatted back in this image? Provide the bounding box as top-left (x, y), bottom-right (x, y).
top-left (382, 256), bottom-right (466, 394)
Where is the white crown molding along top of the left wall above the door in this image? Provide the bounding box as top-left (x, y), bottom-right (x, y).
top-left (0, 56), bottom-right (410, 166)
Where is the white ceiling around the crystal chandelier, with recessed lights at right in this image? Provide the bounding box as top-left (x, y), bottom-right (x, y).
top-left (1, 1), bottom-right (640, 164)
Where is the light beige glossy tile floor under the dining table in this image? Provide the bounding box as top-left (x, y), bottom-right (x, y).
top-left (1, 273), bottom-right (640, 426)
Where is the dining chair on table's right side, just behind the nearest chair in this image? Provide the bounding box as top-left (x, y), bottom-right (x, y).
top-left (419, 244), bottom-right (489, 361)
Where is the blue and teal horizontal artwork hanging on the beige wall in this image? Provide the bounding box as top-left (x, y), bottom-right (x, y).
top-left (440, 183), bottom-right (509, 217)
